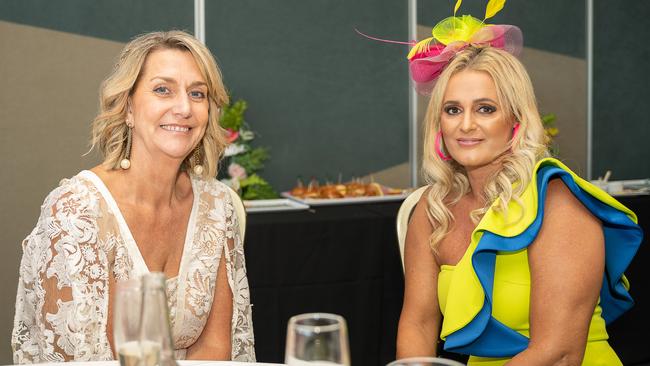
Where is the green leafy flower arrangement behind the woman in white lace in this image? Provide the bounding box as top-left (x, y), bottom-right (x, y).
top-left (220, 99), bottom-right (278, 200)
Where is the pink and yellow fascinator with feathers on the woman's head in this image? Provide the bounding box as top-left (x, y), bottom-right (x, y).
top-left (407, 0), bottom-right (524, 94)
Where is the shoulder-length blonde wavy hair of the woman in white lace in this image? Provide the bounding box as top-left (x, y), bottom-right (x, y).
top-left (90, 31), bottom-right (228, 177)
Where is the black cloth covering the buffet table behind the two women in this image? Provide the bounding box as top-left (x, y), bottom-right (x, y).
top-left (245, 196), bottom-right (650, 366)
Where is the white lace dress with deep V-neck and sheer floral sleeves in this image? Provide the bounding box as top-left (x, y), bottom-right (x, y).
top-left (11, 171), bottom-right (255, 363)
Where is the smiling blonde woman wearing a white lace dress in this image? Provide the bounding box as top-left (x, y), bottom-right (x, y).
top-left (11, 31), bottom-right (255, 363)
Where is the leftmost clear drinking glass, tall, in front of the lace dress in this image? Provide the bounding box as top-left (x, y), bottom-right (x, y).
top-left (113, 278), bottom-right (143, 366)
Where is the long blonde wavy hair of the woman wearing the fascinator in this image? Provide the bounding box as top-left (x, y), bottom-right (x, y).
top-left (422, 46), bottom-right (549, 252)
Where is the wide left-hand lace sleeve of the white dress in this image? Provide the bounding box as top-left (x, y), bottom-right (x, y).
top-left (11, 178), bottom-right (113, 363)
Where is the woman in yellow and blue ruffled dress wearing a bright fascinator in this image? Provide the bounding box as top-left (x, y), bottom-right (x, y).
top-left (397, 3), bottom-right (642, 366)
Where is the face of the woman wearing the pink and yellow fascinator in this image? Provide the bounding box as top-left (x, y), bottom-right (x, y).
top-left (440, 69), bottom-right (513, 169)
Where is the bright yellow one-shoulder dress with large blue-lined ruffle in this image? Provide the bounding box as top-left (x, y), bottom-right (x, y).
top-left (438, 158), bottom-right (643, 366)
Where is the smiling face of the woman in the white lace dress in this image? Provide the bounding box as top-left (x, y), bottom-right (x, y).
top-left (127, 49), bottom-right (209, 161)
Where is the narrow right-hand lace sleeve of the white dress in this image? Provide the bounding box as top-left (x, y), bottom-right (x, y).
top-left (224, 192), bottom-right (255, 362)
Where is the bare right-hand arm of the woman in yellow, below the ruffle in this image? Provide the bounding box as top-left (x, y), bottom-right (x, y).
top-left (508, 179), bottom-right (605, 366)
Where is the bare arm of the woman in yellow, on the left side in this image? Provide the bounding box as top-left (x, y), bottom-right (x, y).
top-left (397, 191), bottom-right (441, 359)
